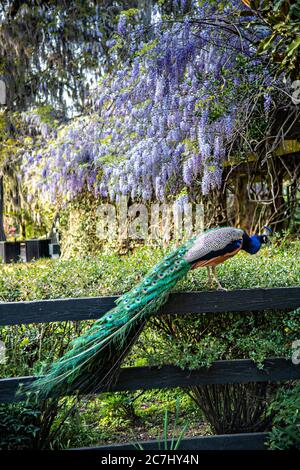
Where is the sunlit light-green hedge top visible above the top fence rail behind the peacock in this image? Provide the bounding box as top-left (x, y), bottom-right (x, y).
top-left (0, 237), bottom-right (300, 301)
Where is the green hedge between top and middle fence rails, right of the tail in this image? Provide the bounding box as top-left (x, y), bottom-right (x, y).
top-left (140, 311), bottom-right (300, 369)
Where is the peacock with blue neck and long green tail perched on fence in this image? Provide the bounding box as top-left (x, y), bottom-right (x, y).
top-left (27, 227), bottom-right (272, 399)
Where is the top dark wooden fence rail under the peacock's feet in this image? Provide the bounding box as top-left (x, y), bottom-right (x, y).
top-left (0, 287), bottom-right (300, 325)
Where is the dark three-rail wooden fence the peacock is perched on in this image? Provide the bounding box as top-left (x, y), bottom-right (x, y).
top-left (0, 287), bottom-right (300, 450)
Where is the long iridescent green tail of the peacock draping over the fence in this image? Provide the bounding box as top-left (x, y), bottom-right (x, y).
top-left (27, 239), bottom-right (194, 399)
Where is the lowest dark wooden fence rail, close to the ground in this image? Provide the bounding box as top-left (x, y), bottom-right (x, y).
top-left (72, 432), bottom-right (268, 451)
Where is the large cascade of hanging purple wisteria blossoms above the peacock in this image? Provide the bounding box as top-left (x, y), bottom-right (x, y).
top-left (22, 4), bottom-right (284, 202)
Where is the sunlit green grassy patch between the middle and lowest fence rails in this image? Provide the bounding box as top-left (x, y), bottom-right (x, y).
top-left (60, 389), bottom-right (211, 447)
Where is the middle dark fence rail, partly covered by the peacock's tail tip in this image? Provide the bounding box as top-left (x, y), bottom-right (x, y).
top-left (0, 358), bottom-right (300, 403)
